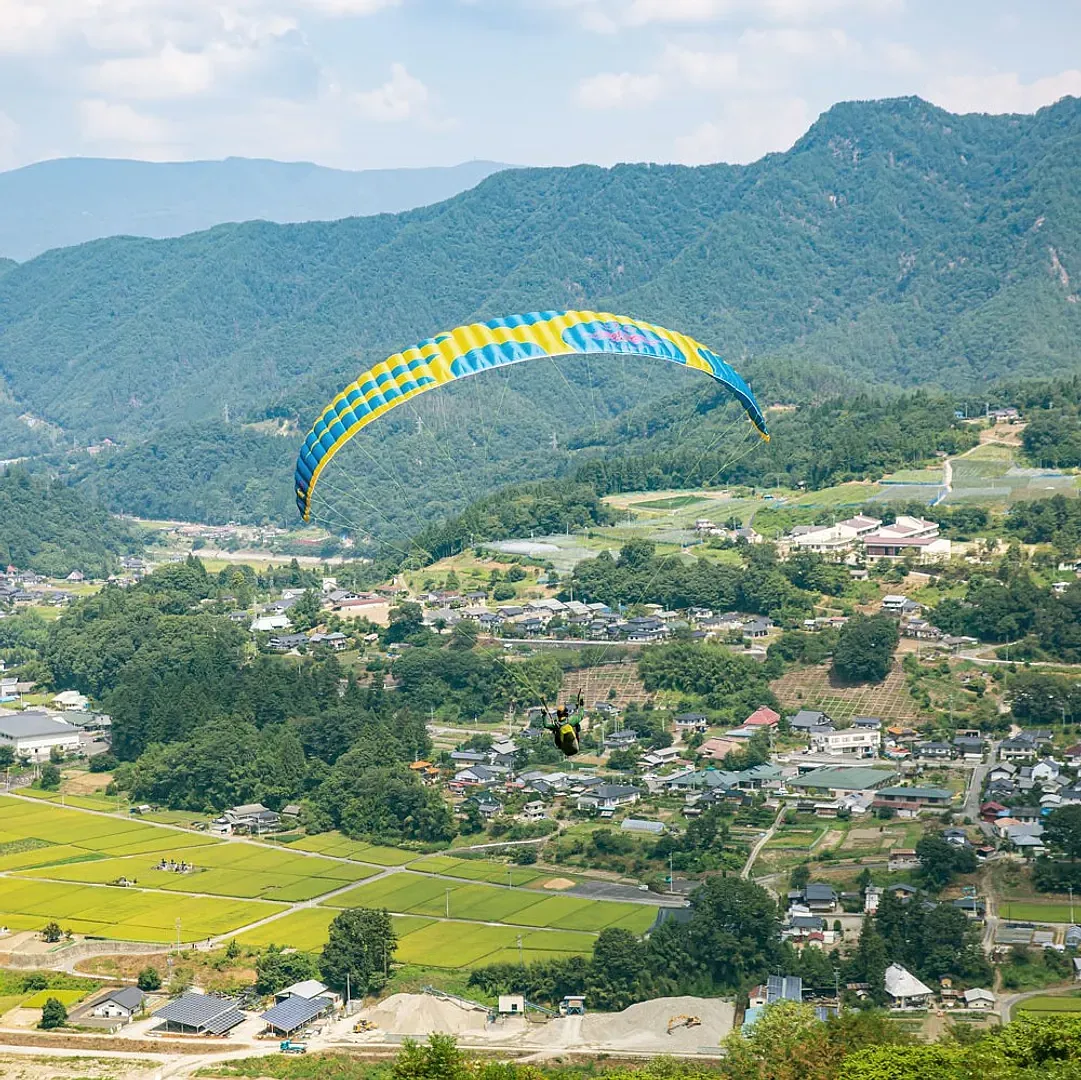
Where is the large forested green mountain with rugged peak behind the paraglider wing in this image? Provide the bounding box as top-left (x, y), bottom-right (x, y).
top-left (0, 98), bottom-right (1081, 529)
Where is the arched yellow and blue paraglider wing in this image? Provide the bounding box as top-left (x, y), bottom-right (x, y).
top-left (295, 311), bottom-right (770, 521)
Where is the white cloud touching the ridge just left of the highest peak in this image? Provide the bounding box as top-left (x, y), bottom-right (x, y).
top-left (676, 97), bottom-right (812, 165)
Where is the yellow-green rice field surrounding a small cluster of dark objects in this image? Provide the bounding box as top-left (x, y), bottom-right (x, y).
top-left (19, 835), bottom-right (378, 903)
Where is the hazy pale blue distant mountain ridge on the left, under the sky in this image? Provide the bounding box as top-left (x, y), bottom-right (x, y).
top-left (0, 158), bottom-right (506, 262)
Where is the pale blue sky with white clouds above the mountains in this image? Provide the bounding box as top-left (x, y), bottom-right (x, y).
top-left (0, 0), bottom-right (1081, 169)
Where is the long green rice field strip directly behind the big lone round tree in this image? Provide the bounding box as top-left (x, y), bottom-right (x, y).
top-left (325, 870), bottom-right (656, 933)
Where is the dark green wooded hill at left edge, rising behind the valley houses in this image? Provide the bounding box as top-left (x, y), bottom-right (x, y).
top-left (0, 468), bottom-right (142, 577)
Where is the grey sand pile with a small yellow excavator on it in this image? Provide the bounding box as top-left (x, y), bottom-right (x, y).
top-left (582, 997), bottom-right (735, 1054)
